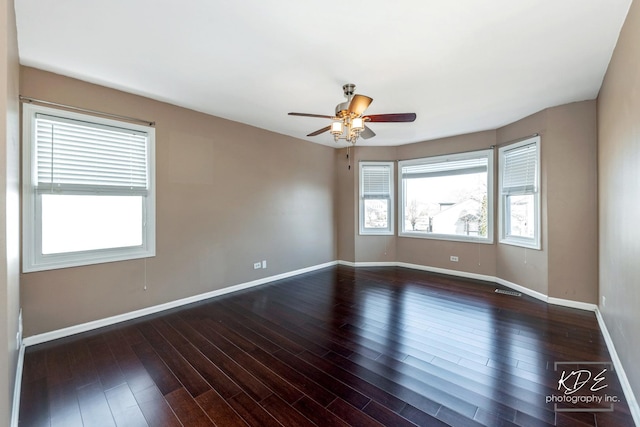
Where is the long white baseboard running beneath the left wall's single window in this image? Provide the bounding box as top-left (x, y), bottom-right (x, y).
top-left (23, 261), bottom-right (337, 347)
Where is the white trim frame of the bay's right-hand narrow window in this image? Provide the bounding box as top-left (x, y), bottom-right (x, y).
top-left (498, 136), bottom-right (542, 250)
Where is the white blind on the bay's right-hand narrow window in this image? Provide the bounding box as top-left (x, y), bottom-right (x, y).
top-left (502, 143), bottom-right (538, 194)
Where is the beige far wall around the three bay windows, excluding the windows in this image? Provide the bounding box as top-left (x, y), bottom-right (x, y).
top-left (338, 101), bottom-right (598, 303)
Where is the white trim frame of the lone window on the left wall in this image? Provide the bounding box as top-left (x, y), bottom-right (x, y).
top-left (22, 104), bottom-right (156, 273)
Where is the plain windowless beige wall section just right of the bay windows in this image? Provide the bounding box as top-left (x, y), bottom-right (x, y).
top-left (542, 100), bottom-right (598, 304)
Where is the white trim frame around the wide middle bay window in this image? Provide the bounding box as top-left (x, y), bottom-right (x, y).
top-left (398, 149), bottom-right (495, 244)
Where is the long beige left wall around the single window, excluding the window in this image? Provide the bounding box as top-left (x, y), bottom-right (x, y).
top-left (21, 68), bottom-right (337, 336)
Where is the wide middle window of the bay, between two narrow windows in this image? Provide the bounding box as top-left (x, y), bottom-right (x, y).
top-left (398, 150), bottom-right (493, 243)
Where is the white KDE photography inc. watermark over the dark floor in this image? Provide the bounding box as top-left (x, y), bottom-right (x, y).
top-left (545, 362), bottom-right (620, 412)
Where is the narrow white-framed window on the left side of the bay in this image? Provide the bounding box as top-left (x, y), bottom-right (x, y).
top-left (360, 162), bottom-right (393, 234)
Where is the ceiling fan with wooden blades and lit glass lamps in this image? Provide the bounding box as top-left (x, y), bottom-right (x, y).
top-left (289, 83), bottom-right (416, 144)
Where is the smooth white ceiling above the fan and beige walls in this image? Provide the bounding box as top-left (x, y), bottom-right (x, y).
top-left (15, 0), bottom-right (631, 146)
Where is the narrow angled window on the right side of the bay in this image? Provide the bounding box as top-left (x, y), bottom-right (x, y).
top-left (499, 136), bottom-right (540, 249)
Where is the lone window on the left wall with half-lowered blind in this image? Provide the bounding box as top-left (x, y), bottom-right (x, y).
top-left (23, 104), bottom-right (155, 272)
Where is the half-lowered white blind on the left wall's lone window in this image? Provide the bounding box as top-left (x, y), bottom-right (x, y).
top-left (34, 114), bottom-right (149, 195)
